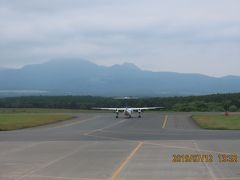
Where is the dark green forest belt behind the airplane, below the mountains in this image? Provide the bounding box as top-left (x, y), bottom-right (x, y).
top-left (0, 93), bottom-right (240, 111)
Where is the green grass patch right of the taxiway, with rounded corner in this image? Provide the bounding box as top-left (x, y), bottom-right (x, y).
top-left (192, 114), bottom-right (240, 130)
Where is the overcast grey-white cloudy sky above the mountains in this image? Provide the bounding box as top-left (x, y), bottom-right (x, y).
top-left (0, 0), bottom-right (240, 76)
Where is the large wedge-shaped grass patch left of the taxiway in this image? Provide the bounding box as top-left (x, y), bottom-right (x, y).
top-left (0, 114), bottom-right (72, 131)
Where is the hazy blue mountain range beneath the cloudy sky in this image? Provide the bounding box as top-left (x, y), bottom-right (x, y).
top-left (0, 59), bottom-right (240, 96)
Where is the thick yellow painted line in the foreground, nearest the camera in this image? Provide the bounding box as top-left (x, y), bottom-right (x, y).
top-left (109, 142), bottom-right (143, 180)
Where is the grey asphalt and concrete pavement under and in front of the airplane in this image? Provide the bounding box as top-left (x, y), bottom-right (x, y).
top-left (0, 112), bottom-right (240, 180)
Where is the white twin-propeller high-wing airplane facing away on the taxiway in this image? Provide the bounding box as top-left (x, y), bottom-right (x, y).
top-left (94, 97), bottom-right (164, 118)
